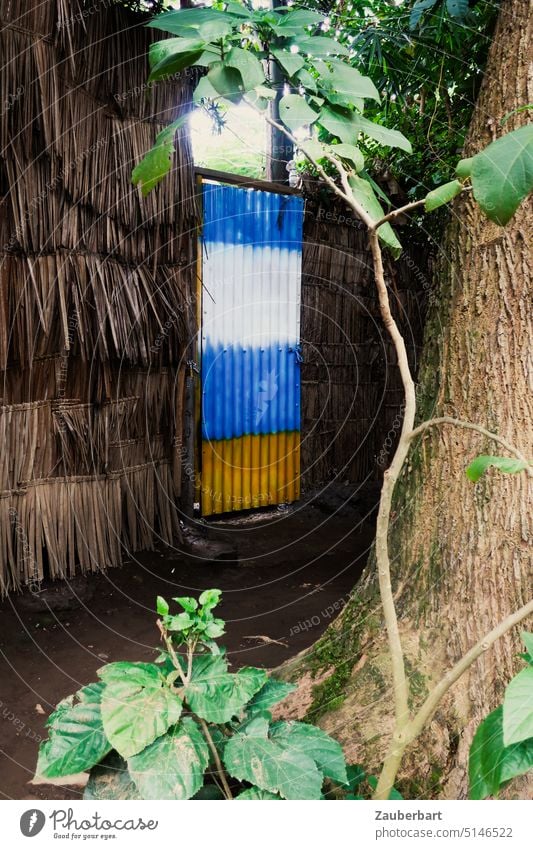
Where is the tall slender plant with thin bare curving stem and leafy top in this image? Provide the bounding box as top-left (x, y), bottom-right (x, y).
top-left (132, 2), bottom-right (533, 799)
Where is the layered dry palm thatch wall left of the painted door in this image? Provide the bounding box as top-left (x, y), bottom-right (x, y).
top-left (0, 0), bottom-right (195, 593)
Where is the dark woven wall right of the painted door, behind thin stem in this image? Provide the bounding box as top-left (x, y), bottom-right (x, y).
top-left (301, 201), bottom-right (429, 489)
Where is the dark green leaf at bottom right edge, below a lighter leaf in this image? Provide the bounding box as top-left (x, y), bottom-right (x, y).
top-left (468, 706), bottom-right (533, 799)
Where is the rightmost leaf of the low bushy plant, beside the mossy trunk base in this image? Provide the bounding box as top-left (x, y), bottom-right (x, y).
top-left (269, 722), bottom-right (348, 784)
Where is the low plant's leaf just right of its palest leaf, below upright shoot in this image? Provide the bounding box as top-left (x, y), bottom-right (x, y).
top-left (184, 655), bottom-right (267, 724)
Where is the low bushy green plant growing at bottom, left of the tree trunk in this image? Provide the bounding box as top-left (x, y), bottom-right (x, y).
top-left (36, 590), bottom-right (350, 800)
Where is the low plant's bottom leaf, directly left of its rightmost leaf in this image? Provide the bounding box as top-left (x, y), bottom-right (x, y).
top-left (224, 725), bottom-right (323, 799)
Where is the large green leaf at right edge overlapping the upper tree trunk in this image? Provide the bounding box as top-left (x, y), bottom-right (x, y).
top-left (471, 124), bottom-right (533, 226)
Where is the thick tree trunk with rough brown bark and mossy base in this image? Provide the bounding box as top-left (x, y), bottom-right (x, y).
top-left (285, 0), bottom-right (533, 798)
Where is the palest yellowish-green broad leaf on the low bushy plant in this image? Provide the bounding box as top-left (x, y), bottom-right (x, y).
top-left (98, 663), bottom-right (182, 758)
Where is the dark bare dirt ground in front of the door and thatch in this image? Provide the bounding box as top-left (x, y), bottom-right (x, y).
top-left (0, 487), bottom-right (376, 800)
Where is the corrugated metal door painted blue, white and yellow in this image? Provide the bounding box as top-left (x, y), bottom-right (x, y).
top-left (201, 183), bottom-right (303, 515)
